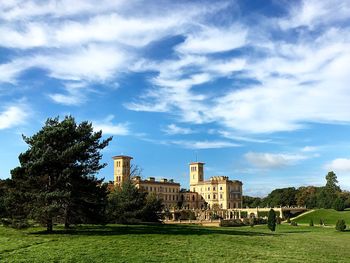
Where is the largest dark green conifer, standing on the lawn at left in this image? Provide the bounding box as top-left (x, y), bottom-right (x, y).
top-left (11, 116), bottom-right (112, 231)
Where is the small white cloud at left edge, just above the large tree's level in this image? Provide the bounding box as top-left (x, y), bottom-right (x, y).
top-left (0, 104), bottom-right (29, 130)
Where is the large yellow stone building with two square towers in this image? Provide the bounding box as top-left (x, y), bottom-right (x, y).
top-left (113, 155), bottom-right (242, 209)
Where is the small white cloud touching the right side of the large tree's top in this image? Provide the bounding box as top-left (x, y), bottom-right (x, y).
top-left (93, 115), bottom-right (130, 136)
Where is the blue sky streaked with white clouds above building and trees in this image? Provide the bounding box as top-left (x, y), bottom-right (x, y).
top-left (0, 0), bottom-right (350, 196)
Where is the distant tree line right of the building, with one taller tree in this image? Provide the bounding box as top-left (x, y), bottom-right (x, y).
top-left (243, 171), bottom-right (350, 211)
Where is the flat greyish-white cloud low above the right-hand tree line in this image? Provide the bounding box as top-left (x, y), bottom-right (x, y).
top-left (244, 152), bottom-right (310, 169)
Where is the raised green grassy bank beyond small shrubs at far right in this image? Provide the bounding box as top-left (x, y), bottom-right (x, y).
top-left (293, 209), bottom-right (350, 225)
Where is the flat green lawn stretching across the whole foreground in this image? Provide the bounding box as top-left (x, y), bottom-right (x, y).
top-left (0, 225), bottom-right (350, 263)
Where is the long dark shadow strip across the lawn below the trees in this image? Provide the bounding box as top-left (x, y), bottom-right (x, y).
top-left (31, 224), bottom-right (281, 236)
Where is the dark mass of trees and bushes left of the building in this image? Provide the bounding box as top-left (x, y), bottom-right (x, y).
top-left (0, 116), bottom-right (162, 231)
